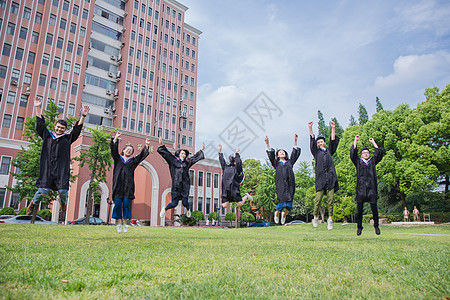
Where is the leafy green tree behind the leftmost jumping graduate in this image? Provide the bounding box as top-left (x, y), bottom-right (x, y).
top-left (7, 100), bottom-right (77, 220)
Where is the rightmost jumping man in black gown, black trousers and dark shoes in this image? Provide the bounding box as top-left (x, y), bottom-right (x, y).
top-left (350, 135), bottom-right (383, 235)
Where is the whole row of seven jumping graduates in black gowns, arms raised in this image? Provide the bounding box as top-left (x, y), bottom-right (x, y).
top-left (27, 98), bottom-right (383, 235)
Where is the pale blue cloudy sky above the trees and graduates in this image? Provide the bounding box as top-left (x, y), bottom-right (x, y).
top-left (180, 0), bottom-right (450, 161)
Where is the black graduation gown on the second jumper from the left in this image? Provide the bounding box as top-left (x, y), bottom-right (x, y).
top-left (110, 139), bottom-right (149, 199)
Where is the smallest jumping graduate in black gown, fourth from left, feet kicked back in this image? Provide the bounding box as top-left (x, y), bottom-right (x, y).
top-left (218, 145), bottom-right (253, 208)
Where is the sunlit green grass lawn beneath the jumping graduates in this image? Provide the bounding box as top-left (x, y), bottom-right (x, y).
top-left (0, 224), bottom-right (450, 299)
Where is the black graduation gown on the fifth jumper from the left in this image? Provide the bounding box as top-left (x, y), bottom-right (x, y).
top-left (267, 147), bottom-right (301, 203)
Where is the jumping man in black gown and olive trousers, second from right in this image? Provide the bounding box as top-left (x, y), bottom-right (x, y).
top-left (308, 121), bottom-right (339, 230)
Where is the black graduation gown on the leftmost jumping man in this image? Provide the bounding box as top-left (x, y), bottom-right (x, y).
top-left (36, 116), bottom-right (83, 190)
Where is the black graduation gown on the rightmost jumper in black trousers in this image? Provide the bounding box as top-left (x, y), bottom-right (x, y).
top-left (350, 145), bottom-right (383, 203)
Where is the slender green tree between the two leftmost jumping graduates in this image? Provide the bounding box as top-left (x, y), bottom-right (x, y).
top-left (74, 125), bottom-right (112, 225)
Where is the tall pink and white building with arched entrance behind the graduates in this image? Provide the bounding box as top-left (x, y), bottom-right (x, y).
top-left (0, 0), bottom-right (225, 226)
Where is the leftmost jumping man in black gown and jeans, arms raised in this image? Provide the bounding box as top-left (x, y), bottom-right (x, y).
top-left (26, 97), bottom-right (89, 215)
